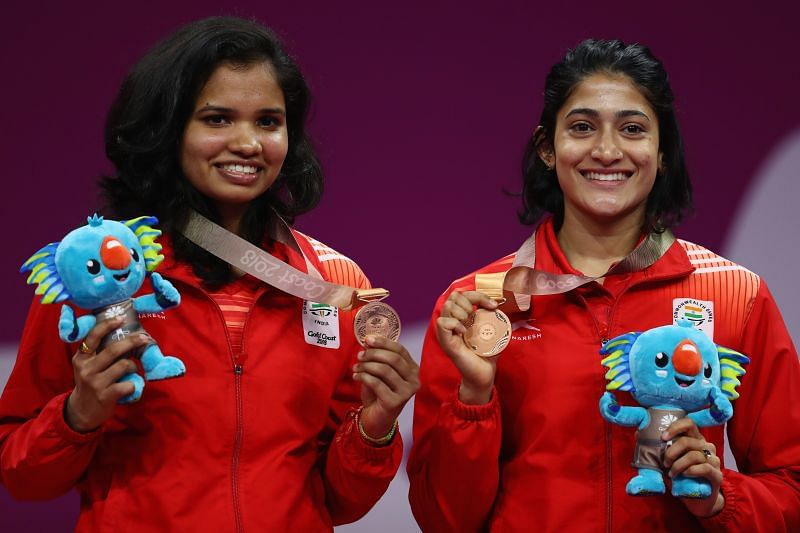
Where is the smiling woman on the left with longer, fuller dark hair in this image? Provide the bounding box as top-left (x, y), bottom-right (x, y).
top-left (0, 17), bottom-right (418, 531)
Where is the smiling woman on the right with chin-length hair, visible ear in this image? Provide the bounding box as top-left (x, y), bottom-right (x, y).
top-left (408, 40), bottom-right (800, 531)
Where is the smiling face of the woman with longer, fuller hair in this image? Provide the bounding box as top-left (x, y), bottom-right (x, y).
top-left (180, 63), bottom-right (289, 231)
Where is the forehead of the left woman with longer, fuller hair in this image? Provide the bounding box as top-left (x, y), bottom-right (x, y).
top-left (197, 61), bottom-right (283, 106)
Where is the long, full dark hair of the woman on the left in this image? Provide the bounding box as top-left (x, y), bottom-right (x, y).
top-left (100, 17), bottom-right (322, 285)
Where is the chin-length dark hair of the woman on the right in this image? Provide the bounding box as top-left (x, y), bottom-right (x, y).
top-left (519, 39), bottom-right (692, 231)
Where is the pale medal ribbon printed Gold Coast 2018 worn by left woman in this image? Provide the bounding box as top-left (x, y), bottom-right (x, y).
top-left (181, 211), bottom-right (389, 311)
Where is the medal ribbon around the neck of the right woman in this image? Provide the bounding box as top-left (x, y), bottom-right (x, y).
top-left (475, 225), bottom-right (675, 312)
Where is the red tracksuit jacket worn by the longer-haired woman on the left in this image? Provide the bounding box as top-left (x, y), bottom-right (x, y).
top-left (0, 234), bottom-right (402, 532)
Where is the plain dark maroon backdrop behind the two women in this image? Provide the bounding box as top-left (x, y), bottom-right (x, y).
top-left (0, 0), bottom-right (800, 531)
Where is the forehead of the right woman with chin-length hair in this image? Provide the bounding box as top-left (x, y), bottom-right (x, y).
top-left (559, 74), bottom-right (656, 118)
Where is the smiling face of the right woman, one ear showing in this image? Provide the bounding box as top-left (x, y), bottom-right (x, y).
top-left (540, 74), bottom-right (661, 229)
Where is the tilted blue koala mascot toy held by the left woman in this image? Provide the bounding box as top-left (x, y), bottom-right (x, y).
top-left (20, 215), bottom-right (186, 403)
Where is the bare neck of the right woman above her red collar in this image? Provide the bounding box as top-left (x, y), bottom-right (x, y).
top-left (558, 208), bottom-right (642, 277)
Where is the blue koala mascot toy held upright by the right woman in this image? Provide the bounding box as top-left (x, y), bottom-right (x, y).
top-left (600, 320), bottom-right (750, 498)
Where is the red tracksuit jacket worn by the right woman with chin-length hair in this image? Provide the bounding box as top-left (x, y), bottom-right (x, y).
top-left (408, 217), bottom-right (800, 532)
